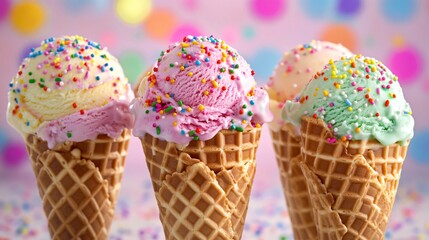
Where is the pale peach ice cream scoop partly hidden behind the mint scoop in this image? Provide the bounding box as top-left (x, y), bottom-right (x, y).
top-left (266, 40), bottom-right (352, 131)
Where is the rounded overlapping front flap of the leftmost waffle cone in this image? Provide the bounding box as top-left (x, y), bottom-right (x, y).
top-left (35, 150), bottom-right (114, 239)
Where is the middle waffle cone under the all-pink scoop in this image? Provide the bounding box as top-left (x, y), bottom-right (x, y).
top-left (141, 127), bottom-right (261, 239)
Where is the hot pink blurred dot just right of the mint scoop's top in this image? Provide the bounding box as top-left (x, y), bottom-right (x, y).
top-left (387, 47), bottom-right (423, 84)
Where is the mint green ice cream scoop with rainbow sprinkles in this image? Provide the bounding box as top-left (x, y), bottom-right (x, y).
top-left (283, 55), bottom-right (414, 145)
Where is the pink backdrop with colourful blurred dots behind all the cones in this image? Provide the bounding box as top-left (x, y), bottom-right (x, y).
top-left (0, 0), bottom-right (429, 239)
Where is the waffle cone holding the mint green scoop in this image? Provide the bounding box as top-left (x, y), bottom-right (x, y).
top-left (300, 117), bottom-right (408, 239)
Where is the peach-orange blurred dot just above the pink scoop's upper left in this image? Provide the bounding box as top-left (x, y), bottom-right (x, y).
top-left (144, 8), bottom-right (178, 39)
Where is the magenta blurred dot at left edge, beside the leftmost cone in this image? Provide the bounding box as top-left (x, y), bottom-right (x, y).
top-left (2, 140), bottom-right (28, 167)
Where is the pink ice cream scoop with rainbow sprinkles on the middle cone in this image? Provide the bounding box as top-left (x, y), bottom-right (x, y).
top-left (132, 36), bottom-right (272, 145)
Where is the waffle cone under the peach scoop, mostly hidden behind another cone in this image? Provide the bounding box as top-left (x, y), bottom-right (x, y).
top-left (271, 123), bottom-right (317, 240)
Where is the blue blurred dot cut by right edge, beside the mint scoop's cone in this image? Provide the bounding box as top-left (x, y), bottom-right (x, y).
top-left (409, 129), bottom-right (429, 164)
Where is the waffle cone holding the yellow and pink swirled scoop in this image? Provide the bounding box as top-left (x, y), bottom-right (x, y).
top-left (26, 130), bottom-right (131, 239)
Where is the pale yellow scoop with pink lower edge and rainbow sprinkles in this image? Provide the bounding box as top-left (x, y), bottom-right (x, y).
top-left (7, 36), bottom-right (133, 147)
